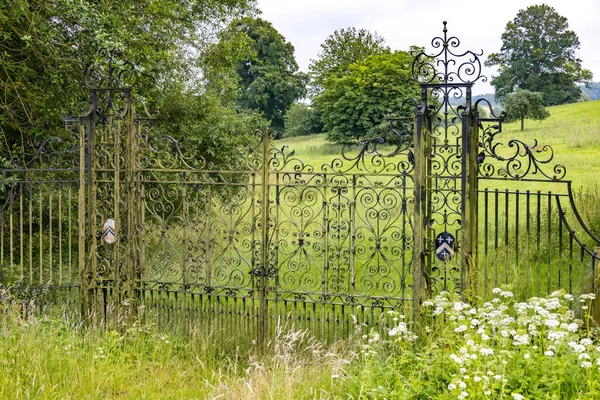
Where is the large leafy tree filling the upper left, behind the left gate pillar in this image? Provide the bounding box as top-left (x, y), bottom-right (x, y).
top-left (0, 0), bottom-right (253, 162)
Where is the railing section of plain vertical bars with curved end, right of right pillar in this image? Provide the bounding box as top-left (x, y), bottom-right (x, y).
top-left (479, 178), bottom-right (598, 298)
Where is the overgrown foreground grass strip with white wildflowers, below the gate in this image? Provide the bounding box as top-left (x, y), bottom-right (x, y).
top-left (0, 289), bottom-right (600, 399)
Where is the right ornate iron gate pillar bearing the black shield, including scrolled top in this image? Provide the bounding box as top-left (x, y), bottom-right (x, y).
top-left (412, 22), bottom-right (486, 310)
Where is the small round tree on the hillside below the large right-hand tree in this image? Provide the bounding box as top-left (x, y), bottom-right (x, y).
top-left (502, 89), bottom-right (550, 131)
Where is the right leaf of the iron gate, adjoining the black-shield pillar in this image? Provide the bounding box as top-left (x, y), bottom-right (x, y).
top-left (268, 122), bottom-right (414, 340)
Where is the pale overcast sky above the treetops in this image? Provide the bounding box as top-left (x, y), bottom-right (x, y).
top-left (258, 0), bottom-right (600, 94)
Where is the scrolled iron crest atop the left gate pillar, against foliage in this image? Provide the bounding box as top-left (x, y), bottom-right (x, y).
top-left (84, 48), bottom-right (139, 89)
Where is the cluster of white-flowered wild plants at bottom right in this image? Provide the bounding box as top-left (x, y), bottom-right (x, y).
top-left (418, 288), bottom-right (600, 399)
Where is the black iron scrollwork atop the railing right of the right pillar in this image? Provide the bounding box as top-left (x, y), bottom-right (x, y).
top-left (475, 99), bottom-right (567, 181)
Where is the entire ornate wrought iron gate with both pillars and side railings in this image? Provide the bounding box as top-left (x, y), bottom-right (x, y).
top-left (0, 25), bottom-right (600, 341)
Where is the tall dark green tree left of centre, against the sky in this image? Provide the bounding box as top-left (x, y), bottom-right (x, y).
top-left (211, 17), bottom-right (305, 129)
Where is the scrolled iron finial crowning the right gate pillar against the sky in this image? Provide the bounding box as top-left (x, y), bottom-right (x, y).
top-left (412, 21), bottom-right (487, 84)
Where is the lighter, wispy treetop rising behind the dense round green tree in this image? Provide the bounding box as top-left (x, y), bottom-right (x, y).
top-left (309, 27), bottom-right (390, 95)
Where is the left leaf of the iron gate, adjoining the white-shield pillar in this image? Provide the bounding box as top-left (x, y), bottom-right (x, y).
top-left (135, 126), bottom-right (264, 340)
